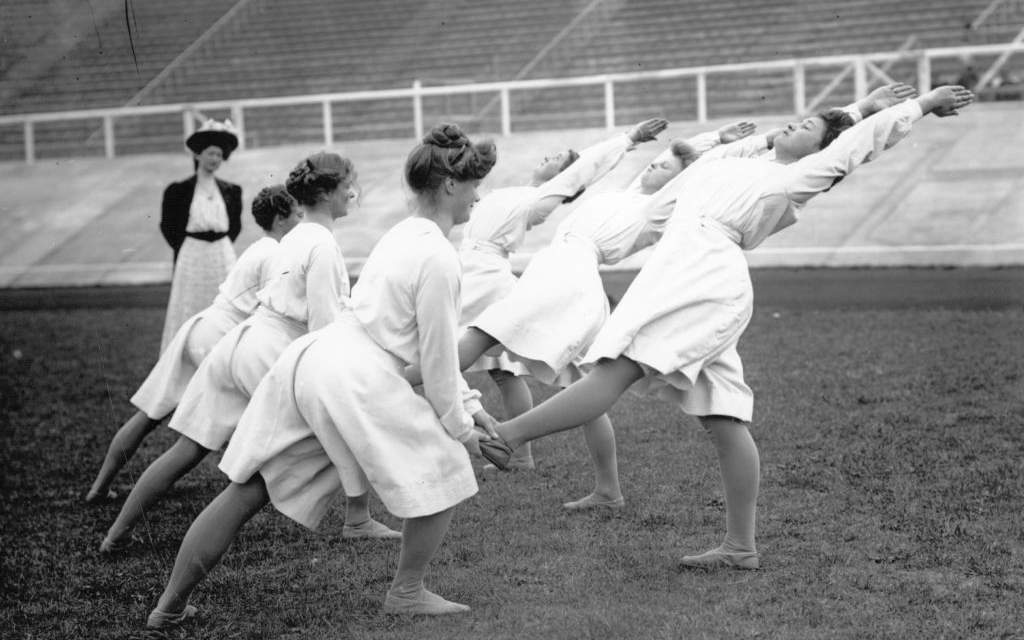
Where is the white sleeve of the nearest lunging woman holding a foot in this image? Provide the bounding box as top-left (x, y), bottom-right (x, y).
top-left (416, 248), bottom-right (479, 441)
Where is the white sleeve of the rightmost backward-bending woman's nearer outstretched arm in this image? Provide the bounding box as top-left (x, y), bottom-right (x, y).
top-left (784, 100), bottom-right (923, 205)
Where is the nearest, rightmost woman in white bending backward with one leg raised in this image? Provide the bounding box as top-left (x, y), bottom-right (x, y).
top-left (480, 87), bottom-right (974, 569)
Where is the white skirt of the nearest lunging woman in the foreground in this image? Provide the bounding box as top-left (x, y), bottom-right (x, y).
top-left (220, 313), bottom-right (477, 528)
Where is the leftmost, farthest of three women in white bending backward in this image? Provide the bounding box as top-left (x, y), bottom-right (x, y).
top-left (459, 118), bottom-right (669, 469)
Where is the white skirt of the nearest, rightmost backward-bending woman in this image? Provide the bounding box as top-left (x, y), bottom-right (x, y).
top-left (584, 219), bottom-right (754, 422)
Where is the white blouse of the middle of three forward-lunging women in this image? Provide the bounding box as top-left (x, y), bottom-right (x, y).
top-left (256, 222), bottom-right (350, 331)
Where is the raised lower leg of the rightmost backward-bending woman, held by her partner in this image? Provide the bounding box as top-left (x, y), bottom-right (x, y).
top-left (498, 356), bottom-right (643, 450)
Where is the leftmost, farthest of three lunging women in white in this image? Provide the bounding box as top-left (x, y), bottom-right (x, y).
top-left (85, 184), bottom-right (302, 503)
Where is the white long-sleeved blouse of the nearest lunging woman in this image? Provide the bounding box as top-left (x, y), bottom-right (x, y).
top-left (350, 217), bottom-right (481, 440)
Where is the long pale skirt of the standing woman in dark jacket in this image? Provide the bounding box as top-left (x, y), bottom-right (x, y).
top-left (160, 237), bottom-right (236, 353)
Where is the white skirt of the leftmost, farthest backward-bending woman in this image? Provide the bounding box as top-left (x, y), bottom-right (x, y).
top-left (459, 249), bottom-right (529, 376)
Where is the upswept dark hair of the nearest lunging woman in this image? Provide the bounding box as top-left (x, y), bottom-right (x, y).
top-left (406, 124), bottom-right (498, 194)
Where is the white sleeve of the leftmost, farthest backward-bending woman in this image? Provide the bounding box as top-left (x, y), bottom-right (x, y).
top-left (519, 133), bottom-right (635, 228)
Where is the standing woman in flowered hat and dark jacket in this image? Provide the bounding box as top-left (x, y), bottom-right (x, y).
top-left (160, 120), bottom-right (242, 351)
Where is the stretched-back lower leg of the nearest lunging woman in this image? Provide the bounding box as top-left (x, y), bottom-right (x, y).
top-left (157, 473), bottom-right (269, 612)
